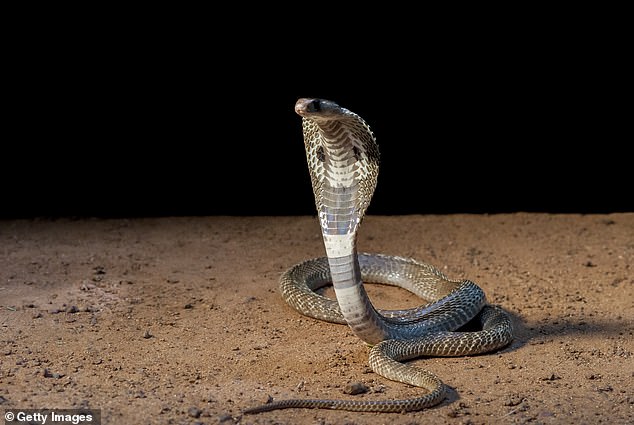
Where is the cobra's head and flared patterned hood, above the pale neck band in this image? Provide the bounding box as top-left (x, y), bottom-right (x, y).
top-left (295, 98), bottom-right (379, 235)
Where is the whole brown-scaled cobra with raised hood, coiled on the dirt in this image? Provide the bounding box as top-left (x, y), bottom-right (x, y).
top-left (244, 99), bottom-right (513, 413)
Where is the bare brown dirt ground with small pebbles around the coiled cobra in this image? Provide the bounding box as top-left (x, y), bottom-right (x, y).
top-left (0, 213), bottom-right (634, 424)
